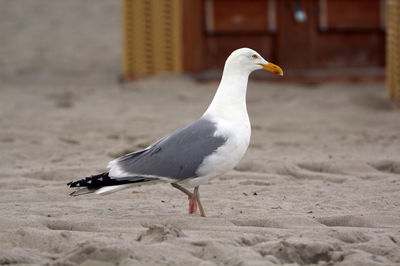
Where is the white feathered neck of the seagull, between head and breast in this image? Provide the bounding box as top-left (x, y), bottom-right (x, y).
top-left (204, 65), bottom-right (250, 121)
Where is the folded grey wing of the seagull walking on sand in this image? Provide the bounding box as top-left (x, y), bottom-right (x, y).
top-left (109, 118), bottom-right (226, 180)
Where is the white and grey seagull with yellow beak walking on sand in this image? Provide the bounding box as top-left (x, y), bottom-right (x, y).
top-left (68, 48), bottom-right (283, 217)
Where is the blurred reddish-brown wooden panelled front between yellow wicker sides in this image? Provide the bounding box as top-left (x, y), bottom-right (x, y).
top-left (183, 0), bottom-right (386, 81)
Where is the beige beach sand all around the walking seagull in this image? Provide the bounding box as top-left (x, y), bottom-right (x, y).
top-left (0, 0), bottom-right (400, 265)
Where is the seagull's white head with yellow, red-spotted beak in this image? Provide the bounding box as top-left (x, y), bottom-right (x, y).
top-left (225, 48), bottom-right (283, 76)
